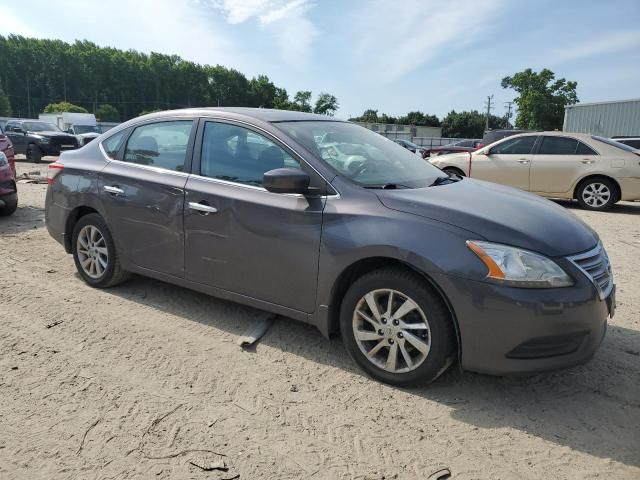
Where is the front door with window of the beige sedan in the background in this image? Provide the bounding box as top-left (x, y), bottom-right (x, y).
top-left (471, 135), bottom-right (538, 190)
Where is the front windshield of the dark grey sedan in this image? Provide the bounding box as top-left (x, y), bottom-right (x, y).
top-left (274, 121), bottom-right (447, 188)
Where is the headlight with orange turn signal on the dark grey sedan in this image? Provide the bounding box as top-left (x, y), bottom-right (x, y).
top-left (467, 240), bottom-right (573, 288)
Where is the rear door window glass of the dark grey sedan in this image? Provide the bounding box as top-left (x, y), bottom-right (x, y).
top-left (124, 120), bottom-right (193, 172)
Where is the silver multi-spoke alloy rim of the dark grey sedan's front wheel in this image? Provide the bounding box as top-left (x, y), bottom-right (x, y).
top-left (352, 289), bottom-right (431, 373)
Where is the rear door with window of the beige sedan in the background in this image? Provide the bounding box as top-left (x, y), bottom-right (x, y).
top-left (531, 135), bottom-right (601, 195)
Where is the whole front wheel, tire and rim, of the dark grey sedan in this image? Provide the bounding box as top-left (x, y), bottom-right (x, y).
top-left (340, 268), bottom-right (455, 386)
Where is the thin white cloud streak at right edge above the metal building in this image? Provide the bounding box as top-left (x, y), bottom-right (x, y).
top-left (547, 30), bottom-right (640, 64)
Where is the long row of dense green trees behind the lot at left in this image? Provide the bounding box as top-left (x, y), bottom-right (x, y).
top-left (0, 35), bottom-right (339, 121)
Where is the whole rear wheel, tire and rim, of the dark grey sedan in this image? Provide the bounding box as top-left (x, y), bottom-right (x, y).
top-left (72, 213), bottom-right (129, 288)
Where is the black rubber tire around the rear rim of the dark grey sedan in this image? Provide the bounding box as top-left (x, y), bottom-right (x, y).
top-left (71, 213), bottom-right (131, 288)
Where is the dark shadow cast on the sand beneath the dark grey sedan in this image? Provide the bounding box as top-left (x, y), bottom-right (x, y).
top-left (109, 276), bottom-right (640, 466)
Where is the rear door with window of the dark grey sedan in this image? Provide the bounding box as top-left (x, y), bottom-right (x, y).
top-left (98, 118), bottom-right (195, 277)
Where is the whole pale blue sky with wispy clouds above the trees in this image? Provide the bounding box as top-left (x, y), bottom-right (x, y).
top-left (0, 0), bottom-right (640, 118)
